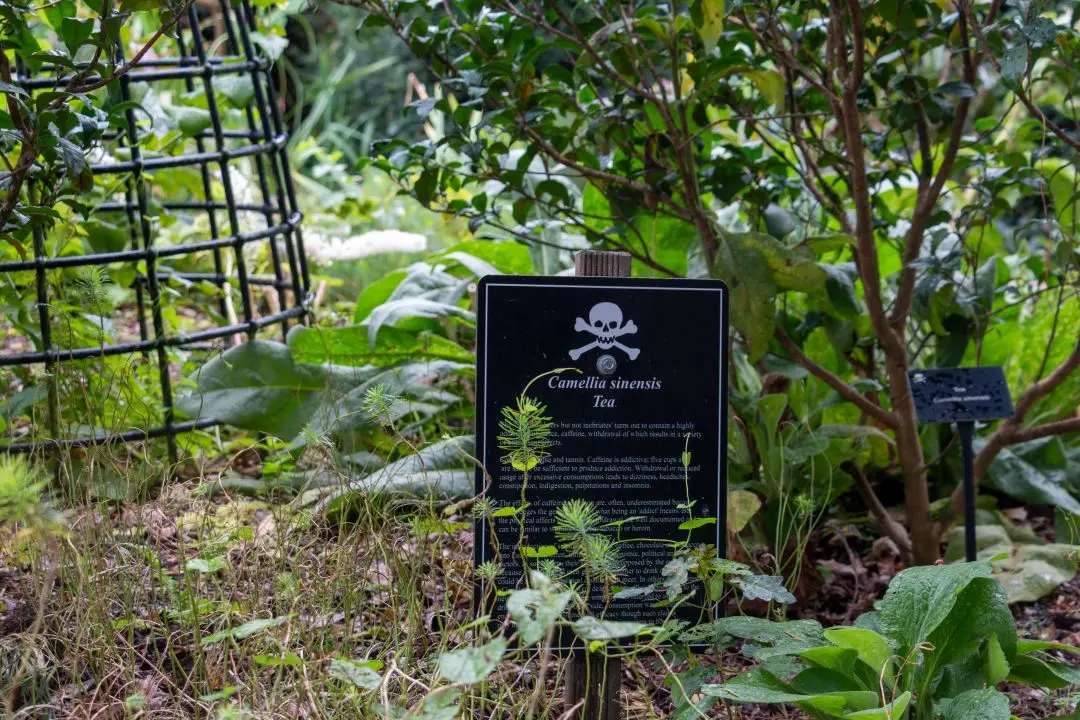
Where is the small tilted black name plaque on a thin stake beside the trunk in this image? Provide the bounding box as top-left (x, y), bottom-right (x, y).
top-left (907, 367), bottom-right (1013, 422)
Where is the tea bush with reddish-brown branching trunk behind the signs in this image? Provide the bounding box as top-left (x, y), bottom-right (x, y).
top-left (353, 0), bottom-right (1080, 563)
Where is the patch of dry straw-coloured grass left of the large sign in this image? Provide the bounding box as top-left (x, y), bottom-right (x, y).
top-left (0, 444), bottom-right (691, 720)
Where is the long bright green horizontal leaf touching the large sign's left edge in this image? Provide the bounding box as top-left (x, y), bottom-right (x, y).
top-left (287, 325), bottom-right (475, 367)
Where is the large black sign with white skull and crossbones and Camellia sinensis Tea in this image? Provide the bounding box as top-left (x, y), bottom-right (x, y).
top-left (476, 276), bottom-right (728, 624)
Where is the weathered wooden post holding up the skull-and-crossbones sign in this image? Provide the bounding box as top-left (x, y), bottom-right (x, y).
top-left (564, 250), bottom-right (630, 720)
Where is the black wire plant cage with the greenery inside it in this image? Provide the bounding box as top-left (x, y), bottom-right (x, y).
top-left (0, 0), bottom-right (310, 462)
